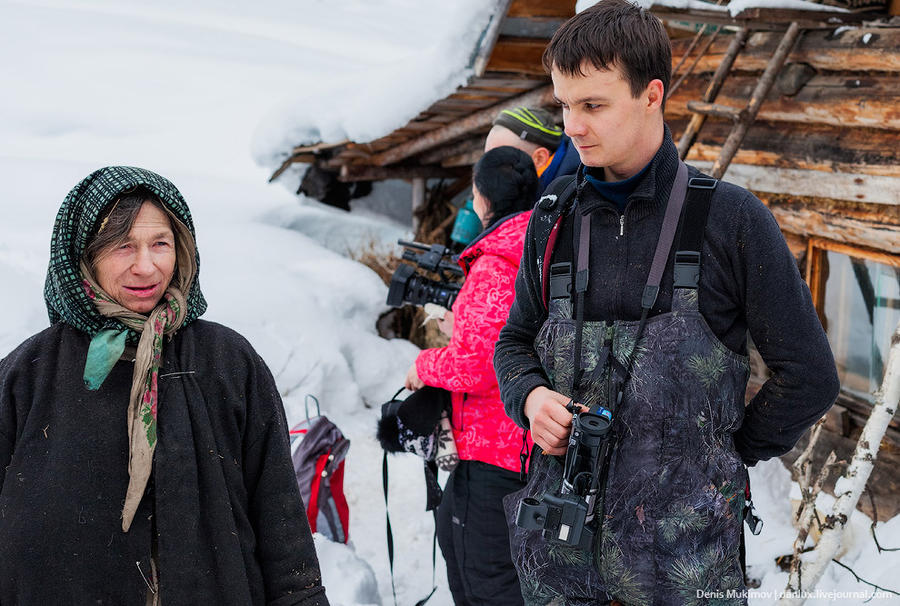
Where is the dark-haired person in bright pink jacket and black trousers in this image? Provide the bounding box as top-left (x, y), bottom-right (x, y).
top-left (406, 147), bottom-right (538, 606)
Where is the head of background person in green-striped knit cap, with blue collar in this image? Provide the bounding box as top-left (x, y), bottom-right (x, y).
top-left (484, 106), bottom-right (581, 198)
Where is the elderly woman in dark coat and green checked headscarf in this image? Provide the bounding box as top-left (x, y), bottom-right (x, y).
top-left (0, 167), bottom-right (327, 605)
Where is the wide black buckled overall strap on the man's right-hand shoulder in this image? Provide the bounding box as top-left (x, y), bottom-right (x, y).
top-left (674, 175), bottom-right (719, 289)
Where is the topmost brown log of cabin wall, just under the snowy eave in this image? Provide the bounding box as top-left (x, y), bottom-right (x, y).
top-left (672, 27), bottom-right (900, 73)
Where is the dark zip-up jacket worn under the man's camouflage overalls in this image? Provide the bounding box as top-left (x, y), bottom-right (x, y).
top-left (494, 128), bottom-right (839, 465)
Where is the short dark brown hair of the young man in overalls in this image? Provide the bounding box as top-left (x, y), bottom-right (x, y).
top-left (542, 0), bottom-right (672, 103)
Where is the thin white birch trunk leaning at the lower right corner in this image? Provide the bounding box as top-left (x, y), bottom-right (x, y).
top-left (778, 324), bottom-right (900, 606)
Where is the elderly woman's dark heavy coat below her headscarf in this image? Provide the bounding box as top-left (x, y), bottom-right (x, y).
top-left (0, 320), bottom-right (327, 606)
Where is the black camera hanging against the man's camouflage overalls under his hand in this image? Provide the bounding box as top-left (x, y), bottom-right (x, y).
top-left (516, 404), bottom-right (612, 551)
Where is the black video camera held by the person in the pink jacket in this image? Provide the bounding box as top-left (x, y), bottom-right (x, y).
top-left (387, 240), bottom-right (463, 309)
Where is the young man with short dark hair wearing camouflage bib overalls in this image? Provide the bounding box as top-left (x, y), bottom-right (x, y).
top-left (494, 0), bottom-right (839, 604)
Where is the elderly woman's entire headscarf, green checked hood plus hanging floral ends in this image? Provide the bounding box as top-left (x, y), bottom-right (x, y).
top-left (44, 166), bottom-right (206, 532)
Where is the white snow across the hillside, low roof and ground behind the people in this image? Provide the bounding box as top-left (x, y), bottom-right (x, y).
top-left (0, 0), bottom-right (900, 606)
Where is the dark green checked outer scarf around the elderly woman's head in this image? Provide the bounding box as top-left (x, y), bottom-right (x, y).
top-left (44, 166), bottom-right (206, 337)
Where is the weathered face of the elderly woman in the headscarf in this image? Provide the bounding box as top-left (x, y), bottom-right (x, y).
top-left (94, 202), bottom-right (175, 314)
